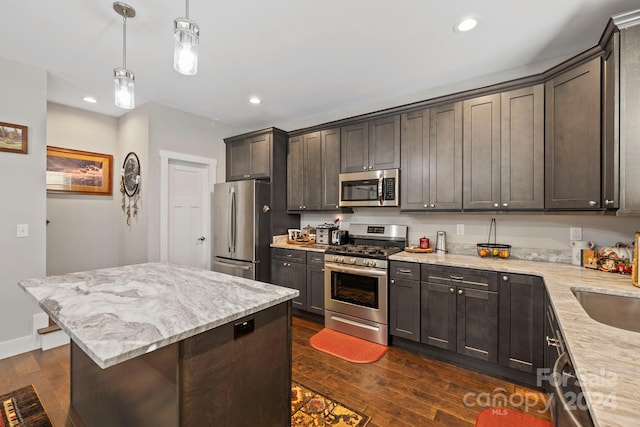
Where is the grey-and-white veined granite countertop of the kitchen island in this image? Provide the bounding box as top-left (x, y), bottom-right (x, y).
top-left (18, 263), bottom-right (298, 368)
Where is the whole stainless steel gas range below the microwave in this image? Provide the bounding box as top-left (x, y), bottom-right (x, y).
top-left (324, 224), bottom-right (407, 345)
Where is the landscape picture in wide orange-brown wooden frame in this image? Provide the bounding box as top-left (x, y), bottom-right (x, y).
top-left (47, 147), bottom-right (113, 196)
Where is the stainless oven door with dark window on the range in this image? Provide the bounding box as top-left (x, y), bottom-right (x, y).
top-left (324, 262), bottom-right (388, 325)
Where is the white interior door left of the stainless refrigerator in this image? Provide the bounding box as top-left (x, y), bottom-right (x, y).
top-left (168, 160), bottom-right (210, 268)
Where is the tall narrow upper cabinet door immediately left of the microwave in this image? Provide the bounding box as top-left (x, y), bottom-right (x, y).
top-left (321, 128), bottom-right (340, 211)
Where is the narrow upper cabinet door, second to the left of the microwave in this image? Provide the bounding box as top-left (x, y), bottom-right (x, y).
top-left (302, 132), bottom-right (323, 211)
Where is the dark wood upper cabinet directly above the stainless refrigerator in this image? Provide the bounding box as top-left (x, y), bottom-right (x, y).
top-left (224, 128), bottom-right (286, 181)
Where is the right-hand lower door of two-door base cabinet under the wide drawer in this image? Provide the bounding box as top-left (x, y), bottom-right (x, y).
top-left (457, 287), bottom-right (498, 363)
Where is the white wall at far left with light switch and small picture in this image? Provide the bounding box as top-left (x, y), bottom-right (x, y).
top-left (0, 59), bottom-right (47, 350)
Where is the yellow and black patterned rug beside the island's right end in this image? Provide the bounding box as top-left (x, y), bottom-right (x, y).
top-left (291, 382), bottom-right (371, 427)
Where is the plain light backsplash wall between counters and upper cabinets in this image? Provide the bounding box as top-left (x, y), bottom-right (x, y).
top-left (300, 208), bottom-right (640, 264)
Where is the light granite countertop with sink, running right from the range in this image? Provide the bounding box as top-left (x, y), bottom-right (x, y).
top-left (390, 252), bottom-right (640, 426)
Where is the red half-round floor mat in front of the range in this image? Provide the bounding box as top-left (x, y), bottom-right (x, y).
top-left (309, 328), bottom-right (389, 363)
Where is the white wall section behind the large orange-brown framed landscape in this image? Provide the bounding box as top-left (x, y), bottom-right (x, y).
top-left (47, 103), bottom-right (122, 275)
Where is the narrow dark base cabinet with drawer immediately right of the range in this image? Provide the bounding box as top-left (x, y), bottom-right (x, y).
top-left (389, 261), bottom-right (420, 342)
